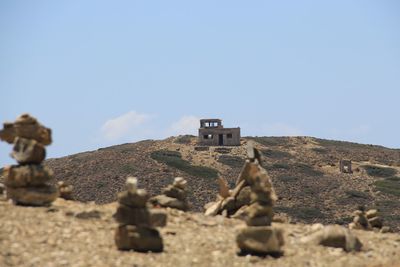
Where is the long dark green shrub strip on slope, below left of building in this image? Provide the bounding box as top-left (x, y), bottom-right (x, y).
top-left (151, 150), bottom-right (218, 178)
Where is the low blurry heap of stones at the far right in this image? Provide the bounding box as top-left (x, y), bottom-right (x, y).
top-left (349, 206), bottom-right (390, 232)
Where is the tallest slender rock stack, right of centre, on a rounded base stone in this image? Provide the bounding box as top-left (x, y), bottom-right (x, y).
top-left (236, 147), bottom-right (284, 255)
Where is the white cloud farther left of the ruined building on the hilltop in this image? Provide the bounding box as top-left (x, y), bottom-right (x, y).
top-left (101, 110), bottom-right (152, 141)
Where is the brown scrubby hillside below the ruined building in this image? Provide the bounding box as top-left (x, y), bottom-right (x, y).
top-left (46, 136), bottom-right (400, 231)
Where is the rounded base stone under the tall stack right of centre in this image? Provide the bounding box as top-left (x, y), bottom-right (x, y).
top-left (236, 226), bottom-right (284, 255)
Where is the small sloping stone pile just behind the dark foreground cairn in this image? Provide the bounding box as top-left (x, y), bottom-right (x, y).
top-left (150, 177), bottom-right (189, 211)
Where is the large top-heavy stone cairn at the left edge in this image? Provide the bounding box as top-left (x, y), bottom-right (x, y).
top-left (0, 114), bottom-right (58, 206)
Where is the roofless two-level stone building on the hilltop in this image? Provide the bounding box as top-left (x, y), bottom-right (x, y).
top-left (199, 119), bottom-right (240, 146)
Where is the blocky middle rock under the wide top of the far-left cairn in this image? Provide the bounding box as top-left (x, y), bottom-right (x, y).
top-left (11, 137), bottom-right (46, 164)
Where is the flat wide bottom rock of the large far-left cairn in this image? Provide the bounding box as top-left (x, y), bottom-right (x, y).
top-left (7, 185), bottom-right (58, 206)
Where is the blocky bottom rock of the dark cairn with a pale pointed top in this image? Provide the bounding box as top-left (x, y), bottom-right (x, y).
top-left (115, 225), bottom-right (164, 252)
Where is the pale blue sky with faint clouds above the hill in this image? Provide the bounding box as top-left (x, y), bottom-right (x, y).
top-left (0, 0), bottom-right (400, 165)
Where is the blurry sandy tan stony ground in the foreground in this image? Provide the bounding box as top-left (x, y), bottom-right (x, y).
top-left (0, 199), bottom-right (400, 267)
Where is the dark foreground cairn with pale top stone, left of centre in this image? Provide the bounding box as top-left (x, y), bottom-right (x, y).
top-left (114, 177), bottom-right (167, 252)
